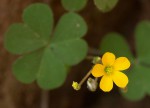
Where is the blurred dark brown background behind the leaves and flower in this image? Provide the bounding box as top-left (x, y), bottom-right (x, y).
top-left (0, 0), bottom-right (150, 108)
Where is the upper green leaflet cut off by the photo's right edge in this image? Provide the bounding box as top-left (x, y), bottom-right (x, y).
top-left (135, 21), bottom-right (150, 64)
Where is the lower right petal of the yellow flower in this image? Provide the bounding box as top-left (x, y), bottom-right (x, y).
top-left (112, 71), bottom-right (128, 88)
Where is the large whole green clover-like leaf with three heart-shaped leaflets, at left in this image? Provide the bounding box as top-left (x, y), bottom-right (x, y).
top-left (5, 4), bottom-right (87, 89)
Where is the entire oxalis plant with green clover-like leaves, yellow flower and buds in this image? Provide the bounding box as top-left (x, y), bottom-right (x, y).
top-left (4, 0), bottom-right (150, 100)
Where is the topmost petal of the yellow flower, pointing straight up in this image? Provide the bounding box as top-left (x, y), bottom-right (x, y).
top-left (102, 52), bottom-right (115, 66)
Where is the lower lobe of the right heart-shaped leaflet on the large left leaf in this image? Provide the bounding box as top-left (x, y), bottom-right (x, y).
top-left (51, 39), bottom-right (88, 65)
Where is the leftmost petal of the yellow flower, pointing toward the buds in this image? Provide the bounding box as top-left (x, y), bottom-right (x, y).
top-left (91, 64), bottom-right (104, 77)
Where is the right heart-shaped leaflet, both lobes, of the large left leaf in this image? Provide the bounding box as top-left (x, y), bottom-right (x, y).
top-left (50, 13), bottom-right (87, 65)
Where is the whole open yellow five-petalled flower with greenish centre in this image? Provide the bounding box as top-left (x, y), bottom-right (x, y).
top-left (91, 52), bottom-right (130, 92)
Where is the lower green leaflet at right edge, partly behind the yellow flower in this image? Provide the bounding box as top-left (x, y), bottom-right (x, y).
top-left (122, 64), bottom-right (150, 101)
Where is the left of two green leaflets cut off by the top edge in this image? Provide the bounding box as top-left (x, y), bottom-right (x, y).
top-left (61, 0), bottom-right (87, 11)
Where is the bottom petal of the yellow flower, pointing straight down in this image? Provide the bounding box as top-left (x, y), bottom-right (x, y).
top-left (100, 75), bottom-right (113, 92)
